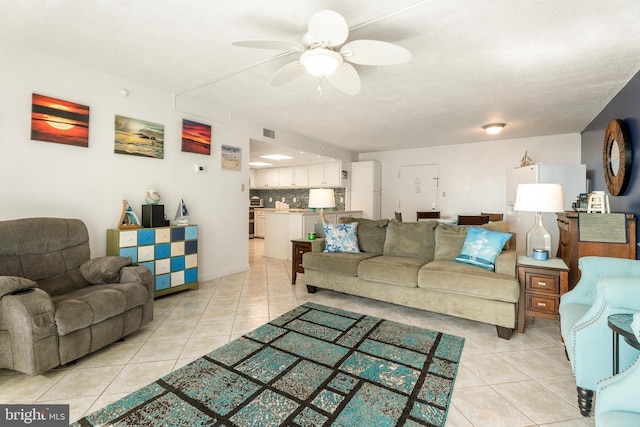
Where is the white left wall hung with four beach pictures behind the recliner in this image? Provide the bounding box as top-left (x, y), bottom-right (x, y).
top-left (0, 44), bottom-right (344, 280)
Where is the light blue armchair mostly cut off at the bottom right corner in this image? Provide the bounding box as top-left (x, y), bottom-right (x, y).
top-left (596, 312), bottom-right (640, 427)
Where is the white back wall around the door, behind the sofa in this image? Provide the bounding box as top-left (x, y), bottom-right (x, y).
top-left (359, 133), bottom-right (580, 218)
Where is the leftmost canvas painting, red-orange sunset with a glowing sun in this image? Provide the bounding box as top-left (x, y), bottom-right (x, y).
top-left (31, 93), bottom-right (89, 147)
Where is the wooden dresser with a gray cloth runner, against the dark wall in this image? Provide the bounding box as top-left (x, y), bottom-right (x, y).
top-left (557, 212), bottom-right (636, 289)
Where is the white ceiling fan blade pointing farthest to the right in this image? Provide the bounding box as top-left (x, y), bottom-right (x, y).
top-left (340, 40), bottom-right (411, 65)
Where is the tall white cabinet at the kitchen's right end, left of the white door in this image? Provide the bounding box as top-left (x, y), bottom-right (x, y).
top-left (351, 160), bottom-right (382, 219)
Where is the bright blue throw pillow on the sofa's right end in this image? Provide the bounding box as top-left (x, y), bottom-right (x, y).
top-left (456, 226), bottom-right (511, 270)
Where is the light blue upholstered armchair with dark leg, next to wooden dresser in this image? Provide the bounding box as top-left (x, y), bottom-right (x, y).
top-left (560, 257), bottom-right (640, 416)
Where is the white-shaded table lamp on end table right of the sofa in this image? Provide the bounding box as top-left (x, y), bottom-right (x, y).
top-left (513, 183), bottom-right (564, 257)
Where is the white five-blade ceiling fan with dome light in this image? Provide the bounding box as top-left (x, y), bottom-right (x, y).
top-left (233, 10), bottom-right (411, 95)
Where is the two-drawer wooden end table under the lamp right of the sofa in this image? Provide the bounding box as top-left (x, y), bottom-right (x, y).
top-left (516, 255), bottom-right (569, 334)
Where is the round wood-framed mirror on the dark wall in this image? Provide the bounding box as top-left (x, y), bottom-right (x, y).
top-left (602, 119), bottom-right (633, 196)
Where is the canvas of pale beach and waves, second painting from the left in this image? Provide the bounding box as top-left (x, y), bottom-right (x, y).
top-left (114, 115), bottom-right (164, 159)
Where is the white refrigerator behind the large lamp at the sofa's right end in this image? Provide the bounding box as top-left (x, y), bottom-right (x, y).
top-left (505, 163), bottom-right (587, 258)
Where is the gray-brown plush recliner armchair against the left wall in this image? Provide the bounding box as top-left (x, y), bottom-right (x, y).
top-left (0, 218), bottom-right (154, 375)
